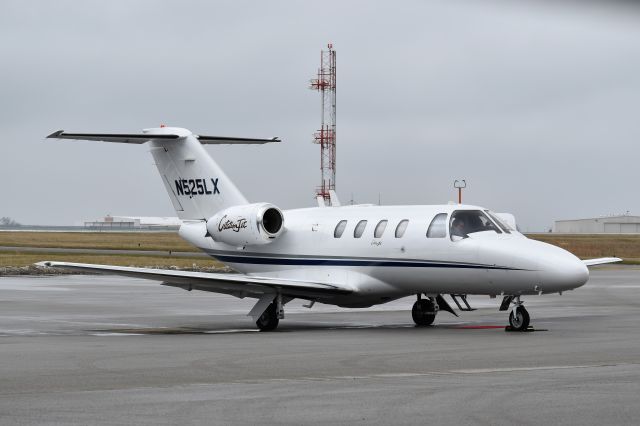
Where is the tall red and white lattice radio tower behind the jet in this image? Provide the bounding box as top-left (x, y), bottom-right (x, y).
top-left (311, 44), bottom-right (338, 205)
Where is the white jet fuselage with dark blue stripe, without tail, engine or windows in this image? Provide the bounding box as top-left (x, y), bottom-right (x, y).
top-left (180, 205), bottom-right (589, 306)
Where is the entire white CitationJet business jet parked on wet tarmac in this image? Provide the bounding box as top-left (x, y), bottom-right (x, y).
top-left (40, 127), bottom-right (620, 331)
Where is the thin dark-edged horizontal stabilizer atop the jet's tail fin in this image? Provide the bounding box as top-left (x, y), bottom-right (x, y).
top-left (47, 130), bottom-right (281, 145)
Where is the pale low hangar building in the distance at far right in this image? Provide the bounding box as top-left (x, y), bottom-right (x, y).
top-left (554, 215), bottom-right (640, 234)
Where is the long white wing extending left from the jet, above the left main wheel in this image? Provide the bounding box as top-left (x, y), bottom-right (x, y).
top-left (36, 262), bottom-right (352, 299)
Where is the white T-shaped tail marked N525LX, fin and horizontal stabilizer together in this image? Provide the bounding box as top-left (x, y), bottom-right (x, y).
top-left (48, 127), bottom-right (280, 220)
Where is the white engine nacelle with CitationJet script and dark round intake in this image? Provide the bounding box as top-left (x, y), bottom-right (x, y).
top-left (207, 203), bottom-right (284, 247)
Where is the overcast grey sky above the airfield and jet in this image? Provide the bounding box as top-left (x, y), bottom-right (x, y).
top-left (0, 0), bottom-right (640, 230)
